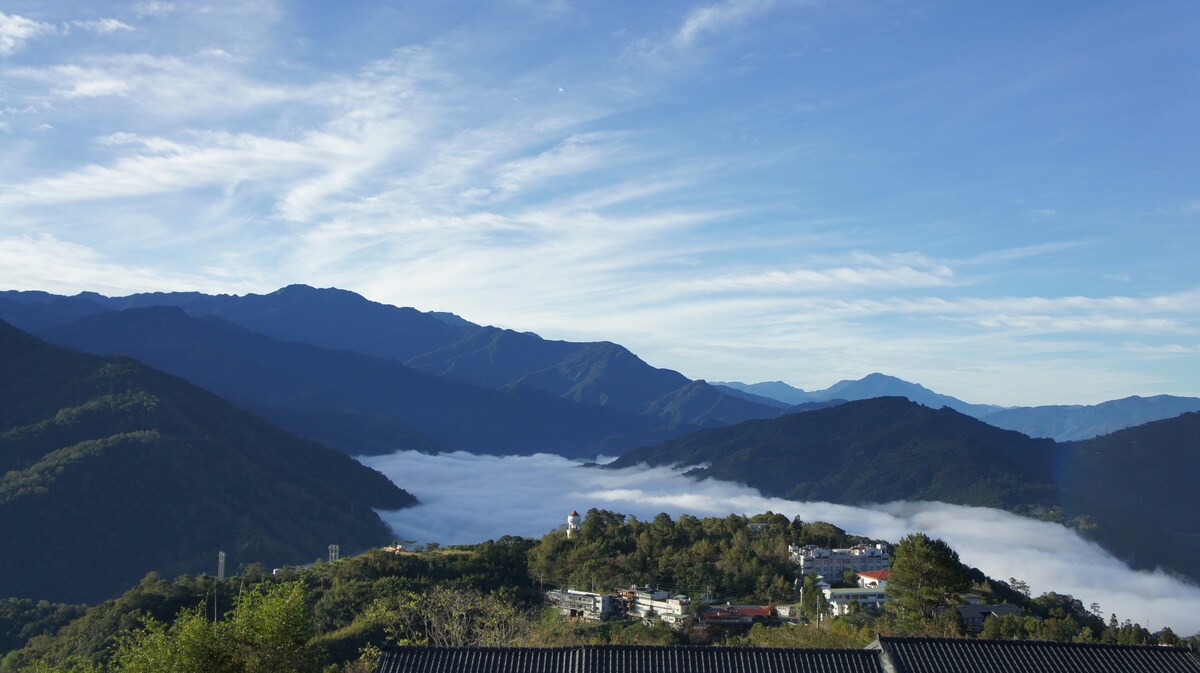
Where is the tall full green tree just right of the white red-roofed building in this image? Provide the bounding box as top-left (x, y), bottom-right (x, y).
top-left (887, 533), bottom-right (971, 632)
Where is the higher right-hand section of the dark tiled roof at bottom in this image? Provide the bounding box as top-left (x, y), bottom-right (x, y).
top-left (872, 638), bottom-right (1200, 673)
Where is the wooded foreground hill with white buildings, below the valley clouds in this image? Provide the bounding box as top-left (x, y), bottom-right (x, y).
top-left (0, 509), bottom-right (1195, 673)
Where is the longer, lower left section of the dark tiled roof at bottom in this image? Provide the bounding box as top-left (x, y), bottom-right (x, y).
top-left (376, 645), bottom-right (883, 673)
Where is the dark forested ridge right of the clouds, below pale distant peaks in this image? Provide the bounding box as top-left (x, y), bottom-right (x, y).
top-left (610, 397), bottom-right (1200, 581)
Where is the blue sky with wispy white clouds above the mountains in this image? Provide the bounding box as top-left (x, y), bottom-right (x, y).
top-left (0, 0), bottom-right (1200, 404)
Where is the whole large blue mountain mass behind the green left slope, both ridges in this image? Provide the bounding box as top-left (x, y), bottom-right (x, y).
top-left (0, 286), bottom-right (782, 457)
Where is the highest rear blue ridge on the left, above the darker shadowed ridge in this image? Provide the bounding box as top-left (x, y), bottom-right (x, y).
top-left (63, 286), bottom-right (779, 426)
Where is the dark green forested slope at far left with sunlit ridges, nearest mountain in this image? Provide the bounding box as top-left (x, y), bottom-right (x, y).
top-left (0, 323), bottom-right (415, 601)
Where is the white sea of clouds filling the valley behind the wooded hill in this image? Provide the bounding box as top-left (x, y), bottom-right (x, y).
top-left (360, 451), bottom-right (1200, 635)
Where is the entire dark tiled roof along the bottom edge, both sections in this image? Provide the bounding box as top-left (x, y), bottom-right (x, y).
top-left (376, 637), bottom-right (1200, 673)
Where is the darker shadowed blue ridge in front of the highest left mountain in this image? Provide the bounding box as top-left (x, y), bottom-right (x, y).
top-left (42, 306), bottom-right (694, 457)
